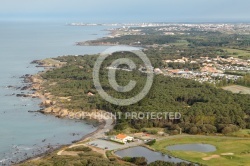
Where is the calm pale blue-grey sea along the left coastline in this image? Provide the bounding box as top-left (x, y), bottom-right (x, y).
top-left (0, 22), bottom-right (109, 165)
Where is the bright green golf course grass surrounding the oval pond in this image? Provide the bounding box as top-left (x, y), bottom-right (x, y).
top-left (152, 136), bottom-right (250, 166)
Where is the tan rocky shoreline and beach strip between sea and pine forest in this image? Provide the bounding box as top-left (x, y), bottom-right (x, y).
top-left (13, 59), bottom-right (113, 165)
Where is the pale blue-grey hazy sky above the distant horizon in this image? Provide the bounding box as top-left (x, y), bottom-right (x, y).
top-left (0, 0), bottom-right (250, 22)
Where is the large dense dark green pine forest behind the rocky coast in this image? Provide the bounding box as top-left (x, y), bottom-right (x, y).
top-left (42, 53), bottom-right (250, 134)
